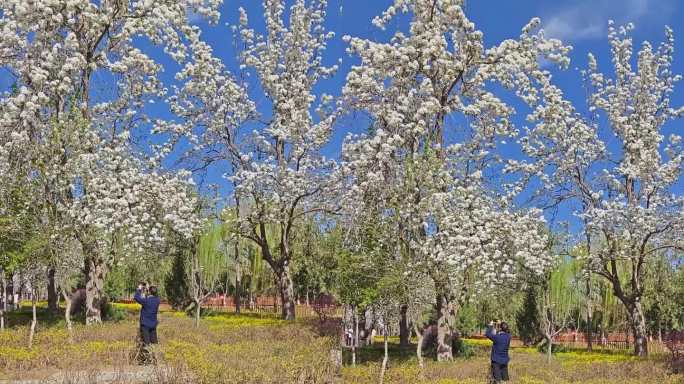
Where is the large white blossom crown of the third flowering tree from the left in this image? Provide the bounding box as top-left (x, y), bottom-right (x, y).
top-left (340, 0), bottom-right (569, 304)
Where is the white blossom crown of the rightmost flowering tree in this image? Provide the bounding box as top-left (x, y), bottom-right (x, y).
top-left (507, 22), bottom-right (684, 268)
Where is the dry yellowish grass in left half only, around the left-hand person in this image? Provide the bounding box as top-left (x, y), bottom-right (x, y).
top-left (0, 308), bottom-right (334, 384)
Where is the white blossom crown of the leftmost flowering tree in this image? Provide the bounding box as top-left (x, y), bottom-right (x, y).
top-left (0, 0), bottom-right (221, 268)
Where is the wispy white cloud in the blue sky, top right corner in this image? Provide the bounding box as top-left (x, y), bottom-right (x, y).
top-left (542, 0), bottom-right (677, 41)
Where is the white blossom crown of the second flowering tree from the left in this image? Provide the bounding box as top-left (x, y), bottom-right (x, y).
top-left (155, 0), bottom-right (336, 248)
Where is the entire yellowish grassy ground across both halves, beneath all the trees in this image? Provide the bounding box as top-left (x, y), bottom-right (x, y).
top-left (0, 304), bottom-right (684, 384)
